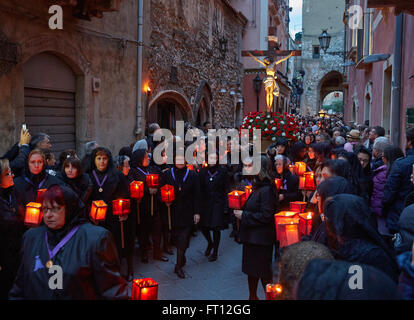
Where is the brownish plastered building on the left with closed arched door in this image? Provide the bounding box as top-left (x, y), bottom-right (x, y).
top-left (0, 0), bottom-right (138, 155)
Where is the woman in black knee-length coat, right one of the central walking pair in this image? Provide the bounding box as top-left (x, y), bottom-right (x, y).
top-left (199, 153), bottom-right (230, 262)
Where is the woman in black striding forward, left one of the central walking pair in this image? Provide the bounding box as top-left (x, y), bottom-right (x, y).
top-left (163, 150), bottom-right (200, 278)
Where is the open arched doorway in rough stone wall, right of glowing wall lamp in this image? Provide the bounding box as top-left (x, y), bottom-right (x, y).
top-left (147, 90), bottom-right (192, 132)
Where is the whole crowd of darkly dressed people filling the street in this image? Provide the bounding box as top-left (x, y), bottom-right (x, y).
top-left (0, 116), bottom-right (414, 300)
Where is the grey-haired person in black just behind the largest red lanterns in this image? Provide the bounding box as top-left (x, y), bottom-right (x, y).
top-left (275, 155), bottom-right (301, 211)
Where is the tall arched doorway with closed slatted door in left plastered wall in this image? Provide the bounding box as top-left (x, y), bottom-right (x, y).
top-left (23, 52), bottom-right (76, 155)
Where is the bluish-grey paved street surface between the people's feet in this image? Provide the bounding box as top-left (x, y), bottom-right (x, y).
top-left (123, 229), bottom-right (277, 300)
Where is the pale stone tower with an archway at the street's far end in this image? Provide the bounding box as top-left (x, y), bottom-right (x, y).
top-left (300, 0), bottom-right (345, 115)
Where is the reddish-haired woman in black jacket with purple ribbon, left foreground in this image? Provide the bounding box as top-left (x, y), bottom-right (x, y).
top-left (9, 185), bottom-right (128, 300)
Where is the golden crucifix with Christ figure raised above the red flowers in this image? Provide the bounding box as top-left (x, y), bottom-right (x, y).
top-left (242, 36), bottom-right (301, 112)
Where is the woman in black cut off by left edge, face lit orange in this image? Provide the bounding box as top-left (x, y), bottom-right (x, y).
top-left (0, 159), bottom-right (25, 300)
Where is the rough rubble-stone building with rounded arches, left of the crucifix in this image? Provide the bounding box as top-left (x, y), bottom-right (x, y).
top-left (143, 0), bottom-right (247, 129)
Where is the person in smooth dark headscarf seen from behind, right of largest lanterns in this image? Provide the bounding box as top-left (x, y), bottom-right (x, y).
top-left (324, 194), bottom-right (399, 282)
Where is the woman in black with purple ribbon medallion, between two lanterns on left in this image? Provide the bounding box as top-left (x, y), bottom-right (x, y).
top-left (90, 147), bottom-right (134, 280)
